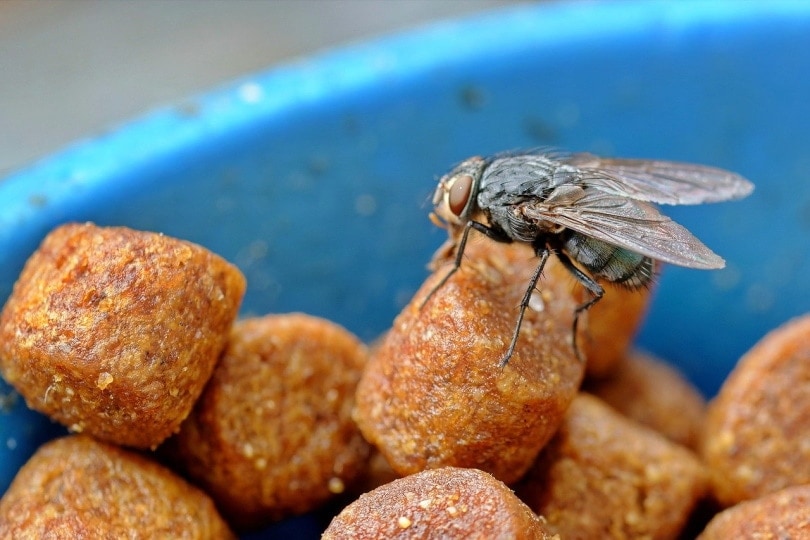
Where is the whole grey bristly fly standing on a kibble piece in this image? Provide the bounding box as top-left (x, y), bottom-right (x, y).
top-left (425, 150), bottom-right (754, 366)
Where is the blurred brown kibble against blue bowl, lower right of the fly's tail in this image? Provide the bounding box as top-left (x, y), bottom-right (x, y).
top-left (585, 351), bottom-right (706, 450)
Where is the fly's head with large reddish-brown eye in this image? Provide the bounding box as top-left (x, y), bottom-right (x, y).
top-left (430, 156), bottom-right (486, 237)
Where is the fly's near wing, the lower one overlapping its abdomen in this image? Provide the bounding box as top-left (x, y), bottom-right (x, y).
top-left (516, 186), bottom-right (725, 270)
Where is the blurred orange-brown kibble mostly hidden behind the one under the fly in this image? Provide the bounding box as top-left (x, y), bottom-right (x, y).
top-left (582, 272), bottom-right (652, 377)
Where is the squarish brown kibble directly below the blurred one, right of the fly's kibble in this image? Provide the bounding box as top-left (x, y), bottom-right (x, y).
top-left (517, 394), bottom-right (707, 540)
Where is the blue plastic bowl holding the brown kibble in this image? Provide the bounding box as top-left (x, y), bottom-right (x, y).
top-left (0, 1), bottom-right (810, 536)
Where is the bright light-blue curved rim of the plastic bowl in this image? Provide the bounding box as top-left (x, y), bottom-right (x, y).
top-left (0, 0), bottom-right (810, 243)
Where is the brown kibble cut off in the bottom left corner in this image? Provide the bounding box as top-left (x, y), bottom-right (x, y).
top-left (0, 435), bottom-right (235, 540)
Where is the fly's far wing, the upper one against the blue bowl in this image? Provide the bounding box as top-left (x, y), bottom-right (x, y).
top-left (563, 154), bottom-right (754, 204)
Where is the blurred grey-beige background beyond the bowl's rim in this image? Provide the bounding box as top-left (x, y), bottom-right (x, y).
top-left (0, 0), bottom-right (515, 177)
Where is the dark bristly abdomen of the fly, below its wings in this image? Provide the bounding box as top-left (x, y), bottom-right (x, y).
top-left (563, 233), bottom-right (655, 289)
